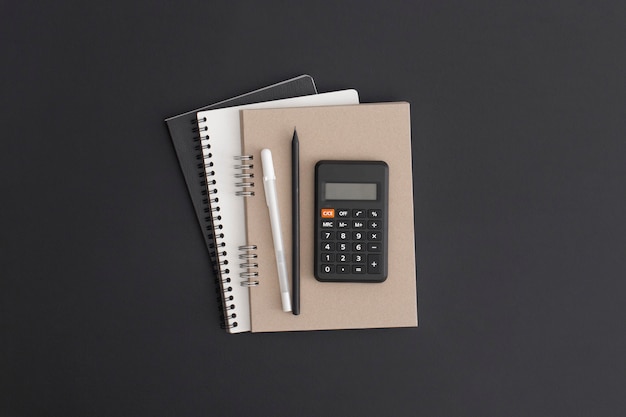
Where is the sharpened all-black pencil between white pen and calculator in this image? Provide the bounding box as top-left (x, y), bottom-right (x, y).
top-left (291, 127), bottom-right (300, 315)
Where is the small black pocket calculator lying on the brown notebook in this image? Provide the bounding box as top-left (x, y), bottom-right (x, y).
top-left (314, 161), bottom-right (389, 282)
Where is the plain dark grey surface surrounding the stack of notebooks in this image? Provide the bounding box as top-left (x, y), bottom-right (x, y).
top-left (0, 1), bottom-right (626, 416)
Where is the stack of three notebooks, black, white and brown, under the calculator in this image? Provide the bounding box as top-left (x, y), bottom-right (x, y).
top-left (166, 75), bottom-right (417, 333)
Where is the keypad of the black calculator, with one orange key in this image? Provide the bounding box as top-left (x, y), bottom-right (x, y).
top-left (318, 208), bottom-right (385, 281)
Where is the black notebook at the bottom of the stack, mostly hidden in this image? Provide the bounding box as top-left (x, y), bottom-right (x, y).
top-left (165, 75), bottom-right (317, 255)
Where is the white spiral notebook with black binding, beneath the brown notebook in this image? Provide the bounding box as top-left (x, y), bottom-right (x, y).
top-left (197, 90), bottom-right (359, 333)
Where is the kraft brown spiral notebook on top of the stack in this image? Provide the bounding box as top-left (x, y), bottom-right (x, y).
top-left (241, 103), bottom-right (417, 332)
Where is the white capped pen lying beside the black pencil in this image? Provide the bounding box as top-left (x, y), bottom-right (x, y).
top-left (261, 149), bottom-right (291, 312)
